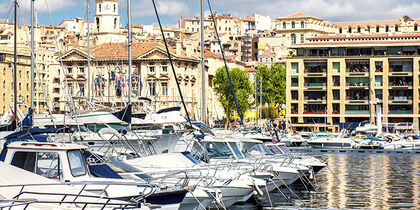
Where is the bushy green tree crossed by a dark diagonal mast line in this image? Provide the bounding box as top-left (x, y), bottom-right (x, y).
top-left (212, 67), bottom-right (253, 121)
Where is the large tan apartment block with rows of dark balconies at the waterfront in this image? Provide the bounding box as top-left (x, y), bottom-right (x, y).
top-left (286, 33), bottom-right (420, 129)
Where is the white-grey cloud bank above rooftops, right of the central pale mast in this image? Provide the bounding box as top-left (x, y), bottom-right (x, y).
top-left (199, 0), bottom-right (420, 21)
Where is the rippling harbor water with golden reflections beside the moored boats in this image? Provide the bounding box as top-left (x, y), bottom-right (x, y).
top-left (232, 153), bottom-right (420, 209)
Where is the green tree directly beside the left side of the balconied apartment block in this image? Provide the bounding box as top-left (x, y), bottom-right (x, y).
top-left (255, 64), bottom-right (286, 108)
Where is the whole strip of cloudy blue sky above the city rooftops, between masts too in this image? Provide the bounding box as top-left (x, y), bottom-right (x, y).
top-left (0, 0), bottom-right (420, 26)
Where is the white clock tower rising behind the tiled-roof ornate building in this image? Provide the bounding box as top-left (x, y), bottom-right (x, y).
top-left (93, 0), bottom-right (126, 44)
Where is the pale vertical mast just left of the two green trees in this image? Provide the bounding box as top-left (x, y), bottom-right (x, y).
top-left (200, 0), bottom-right (206, 123)
